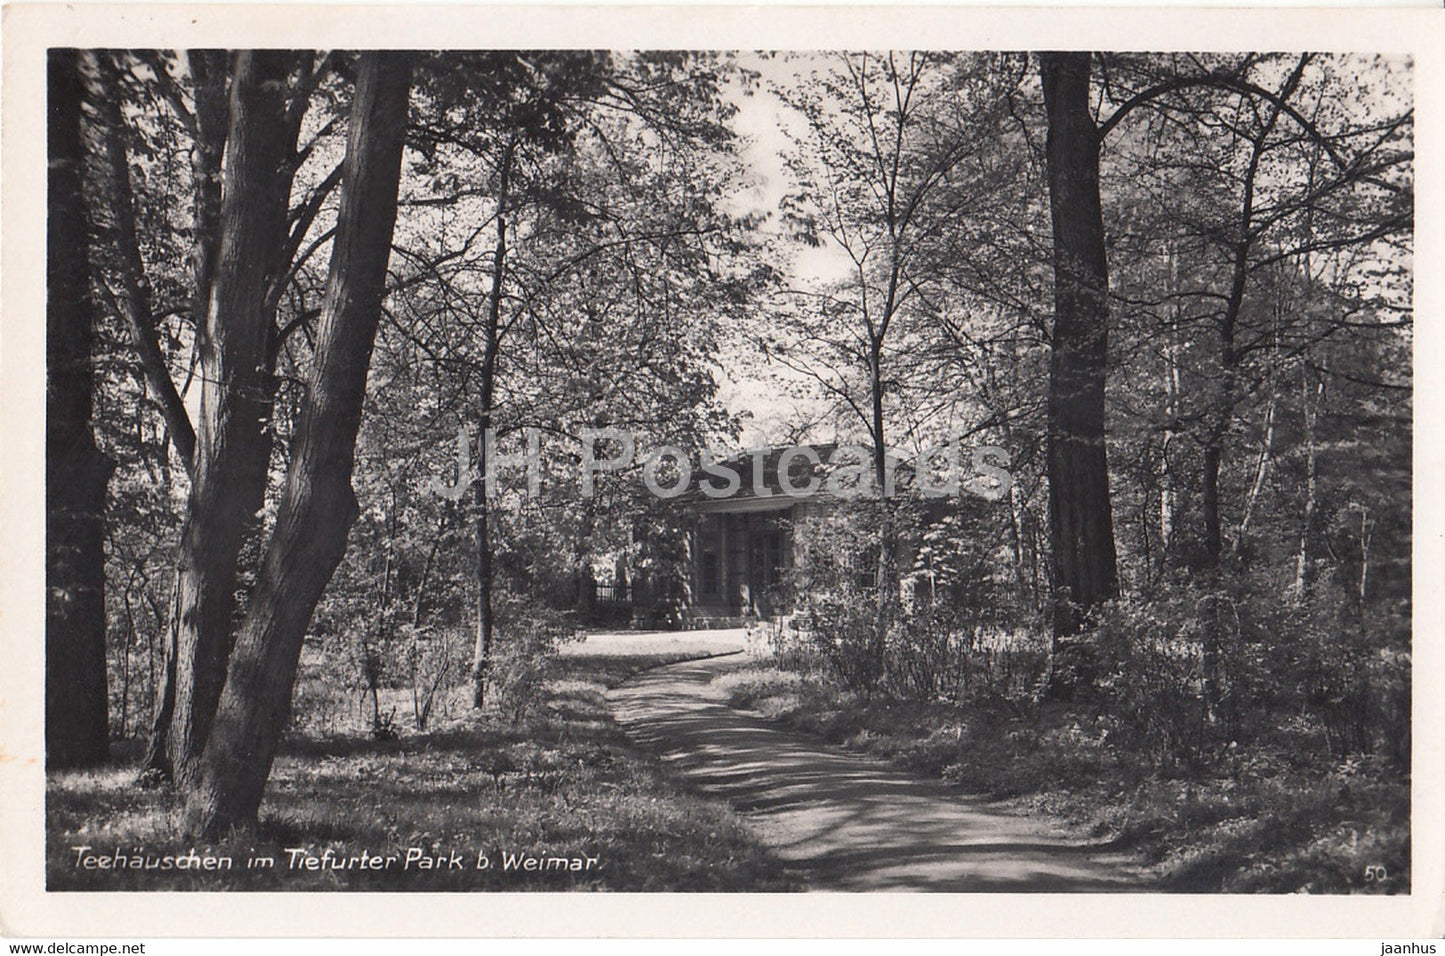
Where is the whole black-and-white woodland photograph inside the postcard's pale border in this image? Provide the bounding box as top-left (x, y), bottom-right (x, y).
top-left (4, 0), bottom-right (1441, 936)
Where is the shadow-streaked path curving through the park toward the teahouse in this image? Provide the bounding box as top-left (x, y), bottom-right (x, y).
top-left (608, 654), bottom-right (1143, 892)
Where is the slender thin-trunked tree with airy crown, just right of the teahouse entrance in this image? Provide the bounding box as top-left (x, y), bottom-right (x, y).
top-left (760, 52), bottom-right (1012, 673)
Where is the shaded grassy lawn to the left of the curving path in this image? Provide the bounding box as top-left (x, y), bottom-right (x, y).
top-left (46, 643), bottom-right (799, 891)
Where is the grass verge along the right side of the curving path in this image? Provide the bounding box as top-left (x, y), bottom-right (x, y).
top-left (717, 663), bottom-right (1410, 894)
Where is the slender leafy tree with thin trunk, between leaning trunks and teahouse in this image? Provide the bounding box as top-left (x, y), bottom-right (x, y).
top-left (399, 51), bottom-right (736, 706)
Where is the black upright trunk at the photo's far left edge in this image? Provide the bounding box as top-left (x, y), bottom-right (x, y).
top-left (45, 51), bottom-right (114, 767)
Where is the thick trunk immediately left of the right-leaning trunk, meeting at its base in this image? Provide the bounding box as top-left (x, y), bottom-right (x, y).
top-left (146, 51), bottom-right (296, 783)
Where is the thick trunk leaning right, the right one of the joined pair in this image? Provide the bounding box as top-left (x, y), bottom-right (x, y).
top-left (186, 53), bottom-right (410, 833)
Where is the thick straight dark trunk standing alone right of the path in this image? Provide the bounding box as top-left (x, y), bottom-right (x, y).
top-left (1039, 53), bottom-right (1118, 646)
